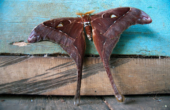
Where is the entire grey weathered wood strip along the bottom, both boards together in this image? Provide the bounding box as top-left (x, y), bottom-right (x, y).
top-left (0, 95), bottom-right (170, 110)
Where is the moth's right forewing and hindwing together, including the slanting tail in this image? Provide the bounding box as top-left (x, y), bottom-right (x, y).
top-left (91, 7), bottom-right (152, 102)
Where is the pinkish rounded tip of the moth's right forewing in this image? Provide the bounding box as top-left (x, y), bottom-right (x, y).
top-left (137, 11), bottom-right (152, 24)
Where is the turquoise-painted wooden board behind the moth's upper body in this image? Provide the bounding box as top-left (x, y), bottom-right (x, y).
top-left (0, 0), bottom-right (170, 56)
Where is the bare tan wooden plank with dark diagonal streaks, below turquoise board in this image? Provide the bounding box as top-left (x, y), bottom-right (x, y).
top-left (0, 56), bottom-right (170, 95)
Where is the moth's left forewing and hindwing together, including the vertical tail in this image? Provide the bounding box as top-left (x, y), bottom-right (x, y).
top-left (28, 18), bottom-right (86, 103)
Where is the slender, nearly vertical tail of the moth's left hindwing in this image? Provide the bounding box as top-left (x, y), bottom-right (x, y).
top-left (74, 64), bottom-right (82, 106)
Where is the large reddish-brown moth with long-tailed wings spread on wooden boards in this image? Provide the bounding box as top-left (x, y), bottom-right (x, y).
top-left (28, 7), bottom-right (152, 105)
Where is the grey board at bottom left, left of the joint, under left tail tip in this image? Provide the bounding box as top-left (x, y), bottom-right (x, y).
top-left (0, 96), bottom-right (108, 110)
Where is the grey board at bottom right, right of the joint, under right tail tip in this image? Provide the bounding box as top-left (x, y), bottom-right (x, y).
top-left (104, 95), bottom-right (170, 110)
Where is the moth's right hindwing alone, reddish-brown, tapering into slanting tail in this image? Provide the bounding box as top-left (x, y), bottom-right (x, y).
top-left (93, 30), bottom-right (124, 102)
